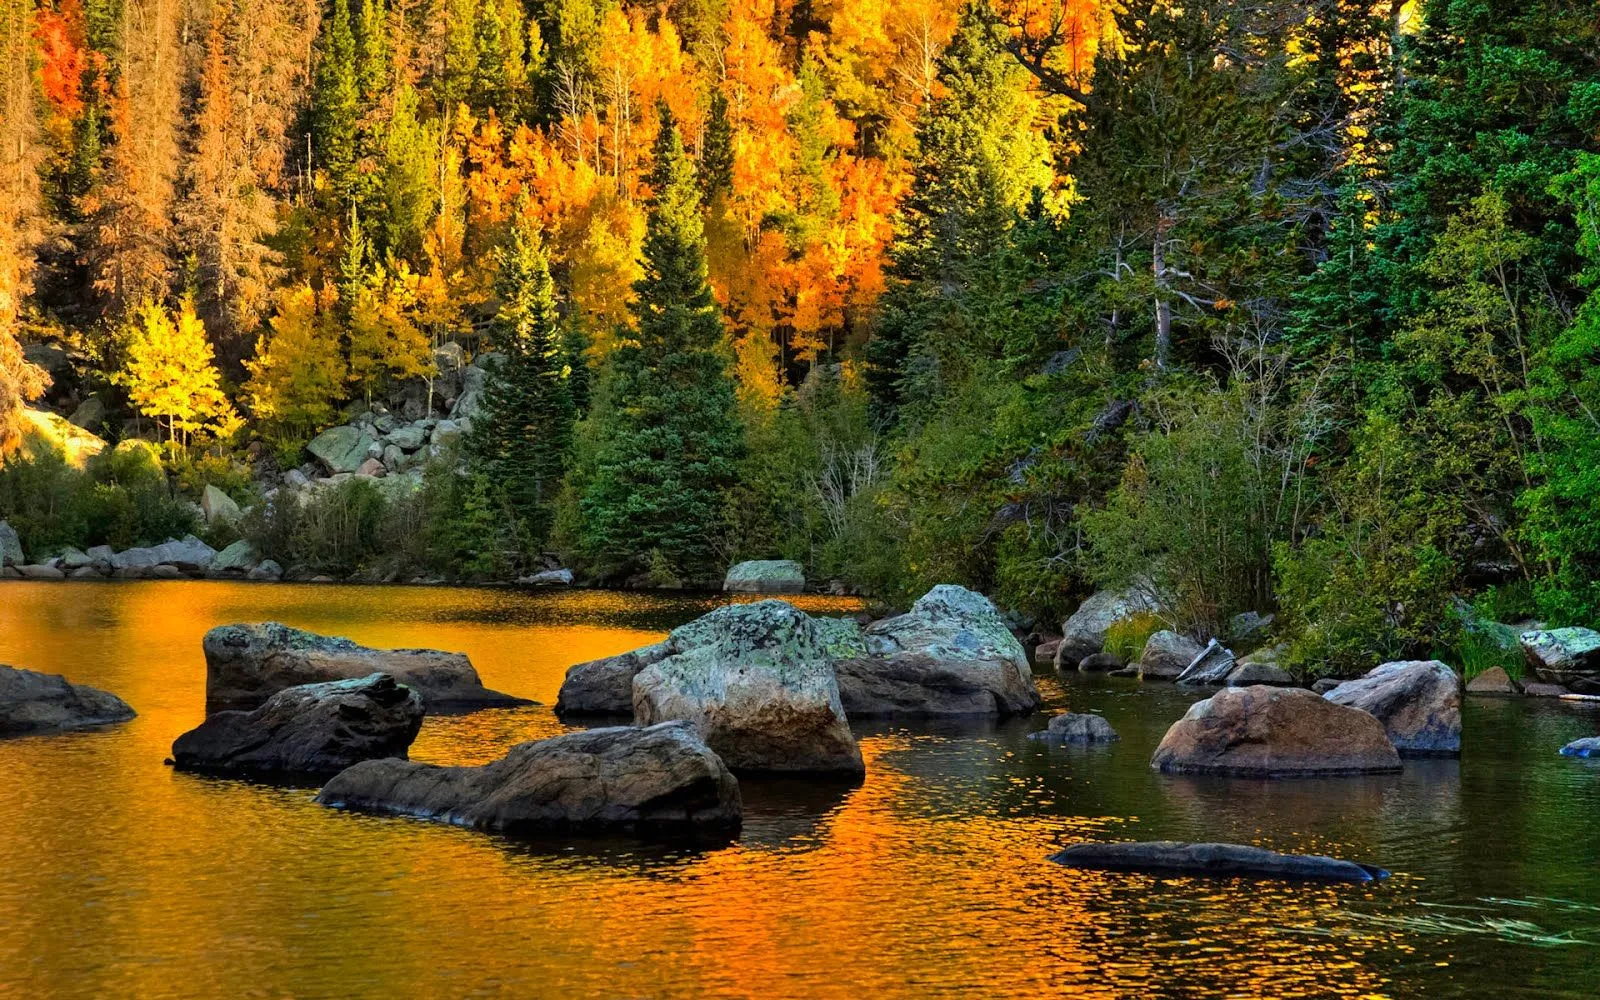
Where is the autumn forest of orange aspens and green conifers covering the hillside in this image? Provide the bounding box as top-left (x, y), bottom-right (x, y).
top-left (0, 0), bottom-right (1600, 670)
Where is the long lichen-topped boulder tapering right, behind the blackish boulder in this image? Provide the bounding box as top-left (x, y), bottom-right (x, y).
top-left (203, 621), bottom-right (528, 712)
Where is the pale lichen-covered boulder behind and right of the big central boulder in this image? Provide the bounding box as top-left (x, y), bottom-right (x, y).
top-left (835, 584), bottom-right (1040, 718)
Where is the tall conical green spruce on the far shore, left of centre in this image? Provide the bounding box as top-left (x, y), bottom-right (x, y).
top-left (581, 102), bottom-right (742, 581)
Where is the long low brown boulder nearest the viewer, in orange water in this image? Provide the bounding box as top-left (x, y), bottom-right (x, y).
top-left (317, 722), bottom-right (742, 834)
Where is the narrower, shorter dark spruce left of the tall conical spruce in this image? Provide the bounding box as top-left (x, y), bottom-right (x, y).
top-left (467, 214), bottom-right (576, 544)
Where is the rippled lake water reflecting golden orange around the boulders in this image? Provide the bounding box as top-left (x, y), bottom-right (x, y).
top-left (0, 581), bottom-right (1600, 998)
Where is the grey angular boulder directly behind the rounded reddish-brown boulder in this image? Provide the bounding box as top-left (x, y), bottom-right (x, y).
top-left (1323, 659), bottom-right (1461, 757)
